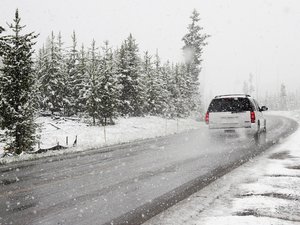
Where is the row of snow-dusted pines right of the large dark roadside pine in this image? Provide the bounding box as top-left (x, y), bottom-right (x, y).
top-left (35, 11), bottom-right (207, 125)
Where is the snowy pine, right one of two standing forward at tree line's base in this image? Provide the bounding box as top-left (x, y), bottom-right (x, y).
top-left (98, 41), bottom-right (120, 126)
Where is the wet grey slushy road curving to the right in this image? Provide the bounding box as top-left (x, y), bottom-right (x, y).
top-left (0, 116), bottom-right (297, 225)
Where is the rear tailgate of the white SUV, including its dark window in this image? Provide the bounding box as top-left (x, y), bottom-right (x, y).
top-left (208, 97), bottom-right (253, 129)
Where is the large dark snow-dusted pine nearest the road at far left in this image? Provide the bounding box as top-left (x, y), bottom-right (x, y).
top-left (0, 10), bottom-right (37, 154)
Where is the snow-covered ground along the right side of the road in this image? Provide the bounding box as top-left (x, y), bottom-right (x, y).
top-left (145, 112), bottom-right (300, 225)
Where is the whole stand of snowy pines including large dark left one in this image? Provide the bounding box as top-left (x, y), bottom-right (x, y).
top-left (0, 10), bottom-right (208, 154)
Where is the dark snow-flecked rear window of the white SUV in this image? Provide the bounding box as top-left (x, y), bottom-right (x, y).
top-left (208, 98), bottom-right (253, 112)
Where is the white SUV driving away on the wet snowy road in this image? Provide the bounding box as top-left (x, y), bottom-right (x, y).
top-left (205, 94), bottom-right (268, 134)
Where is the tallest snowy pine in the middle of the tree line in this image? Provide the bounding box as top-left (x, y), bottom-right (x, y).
top-left (117, 34), bottom-right (146, 116)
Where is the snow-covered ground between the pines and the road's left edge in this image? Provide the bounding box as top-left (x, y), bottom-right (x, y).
top-left (0, 116), bottom-right (204, 163)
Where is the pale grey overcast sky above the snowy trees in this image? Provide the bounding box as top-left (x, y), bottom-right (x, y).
top-left (0, 0), bottom-right (300, 104)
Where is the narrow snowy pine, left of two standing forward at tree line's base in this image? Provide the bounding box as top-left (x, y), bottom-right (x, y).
top-left (83, 40), bottom-right (101, 126)
